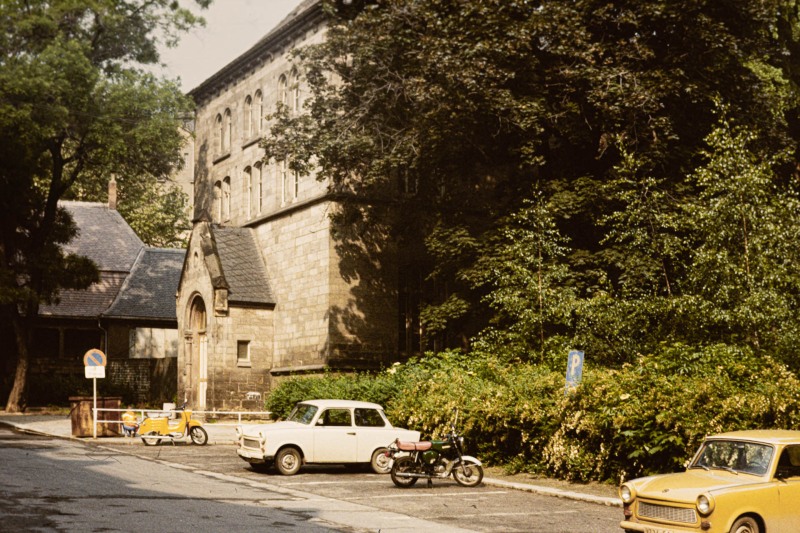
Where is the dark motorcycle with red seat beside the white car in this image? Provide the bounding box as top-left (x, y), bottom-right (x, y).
top-left (385, 412), bottom-right (483, 488)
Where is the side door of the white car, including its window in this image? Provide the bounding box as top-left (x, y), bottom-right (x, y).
top-left (309, 407), bottom-right (357, 463)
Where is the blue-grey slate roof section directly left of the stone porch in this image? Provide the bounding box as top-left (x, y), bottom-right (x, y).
top-left (103, 248), bottom-right (186, 320)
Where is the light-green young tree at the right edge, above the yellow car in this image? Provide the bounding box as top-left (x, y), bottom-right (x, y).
top-left (686, 114), bottom-right (800, 362)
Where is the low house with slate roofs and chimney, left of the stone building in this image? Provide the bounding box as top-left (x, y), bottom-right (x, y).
top-left (30, 200), bottom-right (185, 404)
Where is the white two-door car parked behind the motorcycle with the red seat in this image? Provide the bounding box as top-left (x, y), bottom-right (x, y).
top-left (236, 400), bottom-right (420, 476)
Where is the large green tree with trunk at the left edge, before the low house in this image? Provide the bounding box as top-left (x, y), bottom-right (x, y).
top-left (0, 0), bottom-right (210, 412)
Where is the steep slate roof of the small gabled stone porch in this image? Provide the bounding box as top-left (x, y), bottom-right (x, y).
top-left (213, 227), bottom-right (275, 305)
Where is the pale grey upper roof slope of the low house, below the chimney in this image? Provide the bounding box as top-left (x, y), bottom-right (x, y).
top-left (59, 201), bottom-right (144, 272)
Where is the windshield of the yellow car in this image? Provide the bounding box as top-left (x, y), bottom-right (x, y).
top-left (689, 440), bottom-right (774, 476)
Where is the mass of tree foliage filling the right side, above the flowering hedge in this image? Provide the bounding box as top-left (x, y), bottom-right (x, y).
top-left (263, 0), bottom-right (800, 372)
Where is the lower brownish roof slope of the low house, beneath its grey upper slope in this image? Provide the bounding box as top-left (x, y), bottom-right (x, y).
top-left (39, 272), bottom-right (127, 318)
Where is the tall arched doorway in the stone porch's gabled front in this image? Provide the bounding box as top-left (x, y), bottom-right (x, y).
top-left (186, 295), bottom-right (208, 411)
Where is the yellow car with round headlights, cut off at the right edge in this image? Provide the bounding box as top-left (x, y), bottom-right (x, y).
top-left (619, 430), bottom-right (800, 533)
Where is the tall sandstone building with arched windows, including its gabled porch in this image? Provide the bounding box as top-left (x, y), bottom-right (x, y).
top-left (177, 0), bottom-right (400, 410)
